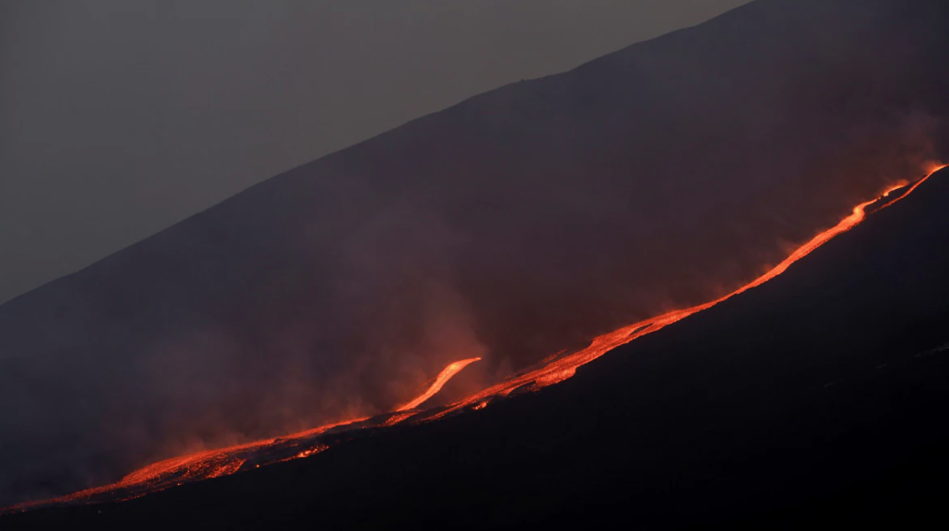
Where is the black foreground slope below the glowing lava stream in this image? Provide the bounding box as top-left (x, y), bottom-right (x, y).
top-left (7, 170), bottom-right (949, 529)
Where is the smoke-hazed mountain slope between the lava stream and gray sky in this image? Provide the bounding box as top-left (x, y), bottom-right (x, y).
top-left (0, 0), bottom-right (949, 503)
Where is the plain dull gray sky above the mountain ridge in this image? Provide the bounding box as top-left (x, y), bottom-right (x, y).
top-left (0, 0), bottom-right (748, 302)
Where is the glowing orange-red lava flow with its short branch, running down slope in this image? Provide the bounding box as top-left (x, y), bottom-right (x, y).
top-left (0, 165), bottom-right (947, 513)
